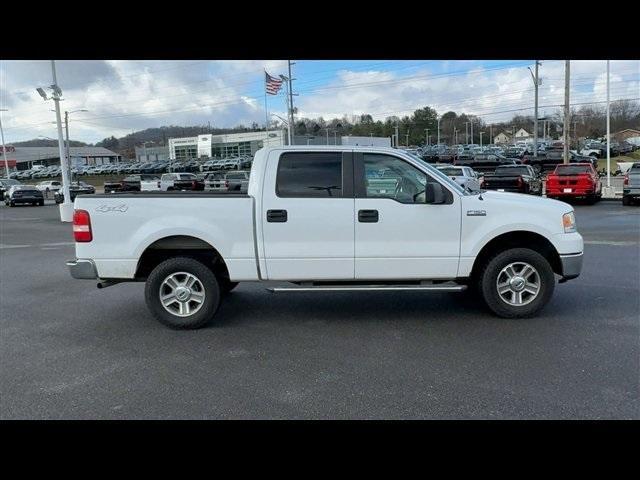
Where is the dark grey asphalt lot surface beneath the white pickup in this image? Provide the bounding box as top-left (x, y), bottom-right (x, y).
top-left (0, 201), bottom-right (640, 419)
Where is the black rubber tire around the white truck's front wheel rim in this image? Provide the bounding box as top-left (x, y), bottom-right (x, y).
top-left (477, 248), bottom-right (555, 318)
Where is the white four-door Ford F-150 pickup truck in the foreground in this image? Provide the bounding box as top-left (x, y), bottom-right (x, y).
top-left (67, 146), bottom-right (583, 328)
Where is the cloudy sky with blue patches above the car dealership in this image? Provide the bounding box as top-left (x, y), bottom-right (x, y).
top-left (0, 60), bottom-right (640, 144)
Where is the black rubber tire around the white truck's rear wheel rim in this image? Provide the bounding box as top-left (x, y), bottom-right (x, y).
top-left (144, 257), bottom-right (221, 330)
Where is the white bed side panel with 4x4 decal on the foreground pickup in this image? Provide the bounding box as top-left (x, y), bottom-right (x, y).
top-left (75, 191), bottom-right (258, 280)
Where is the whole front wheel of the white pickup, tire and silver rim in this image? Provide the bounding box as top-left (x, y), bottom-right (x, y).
top-left (477, 248), bottom-right (555, 318)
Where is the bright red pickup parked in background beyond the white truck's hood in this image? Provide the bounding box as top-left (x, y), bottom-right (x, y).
top-left (547, 163), bottom-right (602, 203)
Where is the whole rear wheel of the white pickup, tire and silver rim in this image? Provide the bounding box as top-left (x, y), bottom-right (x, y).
top-left (145, 257), bottom-right (221, 329)
